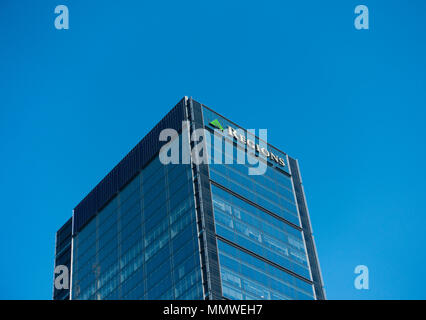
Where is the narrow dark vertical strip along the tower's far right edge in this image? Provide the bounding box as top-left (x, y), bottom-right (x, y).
top-left (288, 157), bottom-right (325, 300)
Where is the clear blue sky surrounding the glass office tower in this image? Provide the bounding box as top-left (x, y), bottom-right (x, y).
top-left (0, 0), bottom-right (426, 299)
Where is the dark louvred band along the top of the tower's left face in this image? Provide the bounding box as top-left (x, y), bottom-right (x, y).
top-left (73, 98), bottom-right (185, 234)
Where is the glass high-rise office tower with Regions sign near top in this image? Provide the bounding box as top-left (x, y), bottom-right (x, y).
top-left (54, 97), bottom-right (325, 299)
